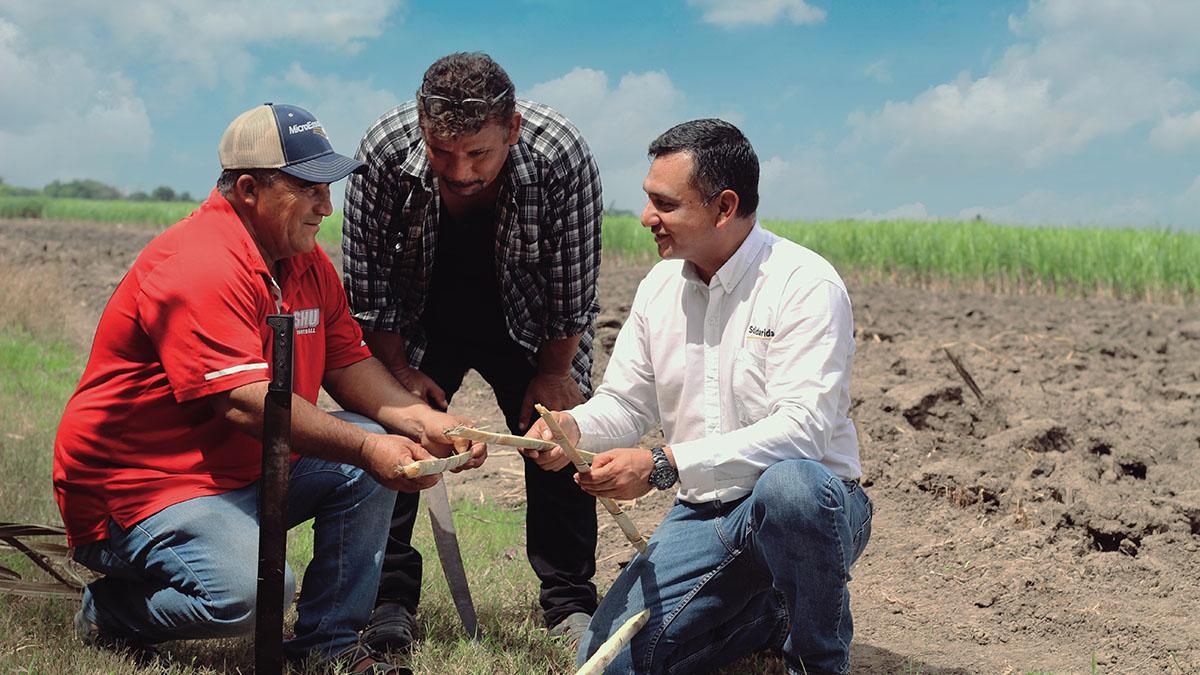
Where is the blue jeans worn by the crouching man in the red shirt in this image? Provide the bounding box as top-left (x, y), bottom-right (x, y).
top-left (74, 437), bottom-right (396, 658)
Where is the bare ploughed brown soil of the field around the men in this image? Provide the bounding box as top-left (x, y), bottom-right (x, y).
top-left (0, 221), bottom-right (1200, 675)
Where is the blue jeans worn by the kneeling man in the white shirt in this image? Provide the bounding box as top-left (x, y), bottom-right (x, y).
top-left (578, 460), bottom-right (874, 674)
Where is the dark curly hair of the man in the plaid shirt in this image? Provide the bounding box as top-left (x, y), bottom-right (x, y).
top-left (416, 52), bottom-right (517, 138)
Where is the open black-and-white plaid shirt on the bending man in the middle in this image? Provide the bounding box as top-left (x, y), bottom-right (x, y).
top-left (342, 98), bottom-right (604, 395)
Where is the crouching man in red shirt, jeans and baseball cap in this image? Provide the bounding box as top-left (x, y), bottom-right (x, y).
top-left (54, 103), bottom-right (486, 673)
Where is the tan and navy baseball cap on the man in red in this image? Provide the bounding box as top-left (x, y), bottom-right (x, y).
top-left (217, 103), bottom-right (366, 183)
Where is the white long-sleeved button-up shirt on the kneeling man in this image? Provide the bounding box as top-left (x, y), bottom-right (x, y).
top-left (571, 223), bottom-right (862, 502)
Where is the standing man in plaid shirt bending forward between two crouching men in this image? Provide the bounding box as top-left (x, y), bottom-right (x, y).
top-left (342, 53), bottom-right (604, 650)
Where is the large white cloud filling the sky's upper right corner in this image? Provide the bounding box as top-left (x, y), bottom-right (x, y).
top-left (847, 0), bottom-right (1200, 168)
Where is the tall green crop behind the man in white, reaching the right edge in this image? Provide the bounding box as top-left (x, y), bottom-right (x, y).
top-left (602, 217), bottom-right (1200, 303)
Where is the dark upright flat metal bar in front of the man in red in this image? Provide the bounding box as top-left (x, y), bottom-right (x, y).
top-left (254, 315), bottom-right (295, 675)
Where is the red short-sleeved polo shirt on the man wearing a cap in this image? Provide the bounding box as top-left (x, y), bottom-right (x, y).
top-left (54, 190), bottom-right (371, 546)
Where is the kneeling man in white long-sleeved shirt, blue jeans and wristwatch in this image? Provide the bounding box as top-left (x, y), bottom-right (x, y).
top-left (529, 119), bottom-right (872, 675)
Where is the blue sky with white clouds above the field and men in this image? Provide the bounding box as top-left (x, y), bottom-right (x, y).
top-left (0, 0), bottom-right (1200, 231)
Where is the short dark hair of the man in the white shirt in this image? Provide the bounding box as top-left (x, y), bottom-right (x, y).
top-left (648, 119), bottom-right (758, 217)
